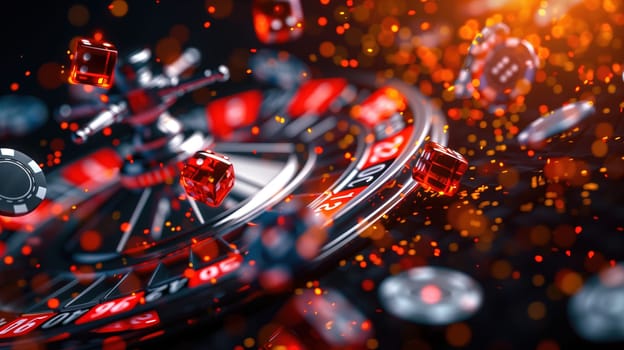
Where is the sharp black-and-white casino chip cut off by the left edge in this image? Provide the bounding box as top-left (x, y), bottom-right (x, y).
top-left (0, 148), bottom-right (47, 216)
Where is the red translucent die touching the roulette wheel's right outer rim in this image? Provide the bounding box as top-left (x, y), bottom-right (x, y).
top-left (412, 141), bottom-right (468, 196)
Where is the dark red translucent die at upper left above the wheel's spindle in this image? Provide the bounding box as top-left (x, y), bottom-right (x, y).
top-left (69, 39), bottom-right (117, 88)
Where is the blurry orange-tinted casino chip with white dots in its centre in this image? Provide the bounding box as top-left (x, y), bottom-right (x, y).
top-left (454, 23), bottom-right (539, 111)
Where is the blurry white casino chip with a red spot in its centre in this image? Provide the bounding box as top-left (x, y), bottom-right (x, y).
top-left (379, 266), bottom-right (483, 325)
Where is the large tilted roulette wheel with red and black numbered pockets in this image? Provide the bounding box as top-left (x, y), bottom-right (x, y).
top-left (0, 69), bottom-right (446, 348)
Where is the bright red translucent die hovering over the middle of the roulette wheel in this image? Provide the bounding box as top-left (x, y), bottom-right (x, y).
top-left (180, 151), bottom-right (234, 207)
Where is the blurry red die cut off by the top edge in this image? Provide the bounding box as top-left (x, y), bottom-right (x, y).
top-left (253, 0), bottom-right (303, 44)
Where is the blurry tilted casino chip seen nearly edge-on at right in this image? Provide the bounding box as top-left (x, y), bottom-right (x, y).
top-left (518, 101), bottom-right (596, 148)
